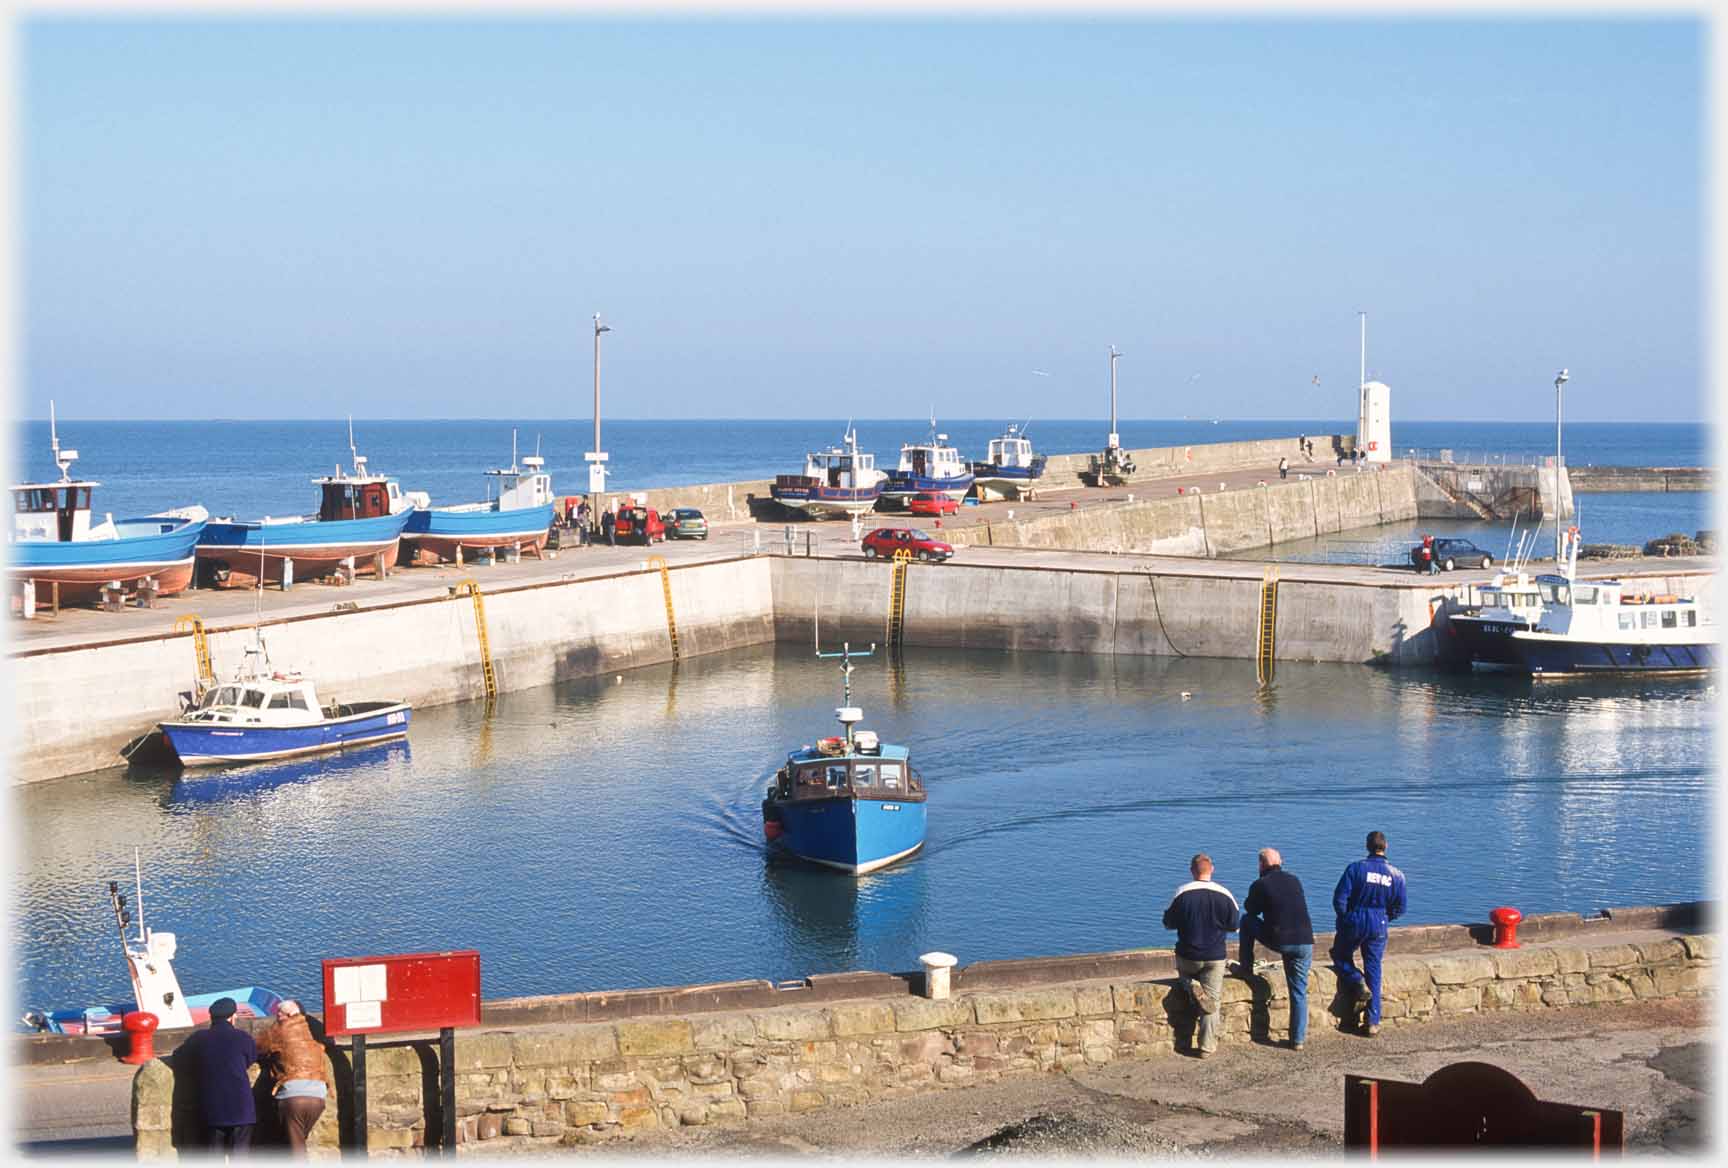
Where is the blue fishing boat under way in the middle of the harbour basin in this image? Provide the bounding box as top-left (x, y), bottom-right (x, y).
top-left (762, 646), bottom-right (926, 876)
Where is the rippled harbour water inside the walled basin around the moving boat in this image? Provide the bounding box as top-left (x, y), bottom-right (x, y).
top-left (12, 644), bottom-right (1714, 1006)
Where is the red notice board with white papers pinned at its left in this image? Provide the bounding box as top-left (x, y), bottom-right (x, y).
top-left (323, 949), bottom-right (480, 1037)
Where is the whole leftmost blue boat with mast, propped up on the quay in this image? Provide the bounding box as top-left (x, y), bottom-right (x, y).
top-left (7, 403), bottom-right (209, 603)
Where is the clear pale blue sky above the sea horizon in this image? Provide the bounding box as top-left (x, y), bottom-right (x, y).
top-left (17, 16), bottom-right (1707, 420)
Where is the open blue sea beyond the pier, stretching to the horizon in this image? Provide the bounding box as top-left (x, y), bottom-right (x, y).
top-left (6, 418), bottom-right (1709, 518)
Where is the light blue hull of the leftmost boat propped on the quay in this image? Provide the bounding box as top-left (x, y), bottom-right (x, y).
top-left (7, 518), bottom-right (207, 605)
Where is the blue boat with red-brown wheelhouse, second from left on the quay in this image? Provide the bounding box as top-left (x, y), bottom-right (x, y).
top-left (197, 425), bottom-right (429, 584)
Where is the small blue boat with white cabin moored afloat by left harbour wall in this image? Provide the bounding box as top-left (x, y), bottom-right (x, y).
top-left (157, 641), bottom-right (413, 767)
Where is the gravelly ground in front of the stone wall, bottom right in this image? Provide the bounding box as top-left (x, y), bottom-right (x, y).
top-left (504, 1000), bottom-right (1718, 1159)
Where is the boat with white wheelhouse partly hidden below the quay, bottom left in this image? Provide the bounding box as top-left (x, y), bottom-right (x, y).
top-left (24, 854), bottom-right (282, 1035)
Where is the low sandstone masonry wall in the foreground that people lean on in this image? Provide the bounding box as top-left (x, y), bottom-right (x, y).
top-left (133, 931), bottom-right (1716, 1156)
